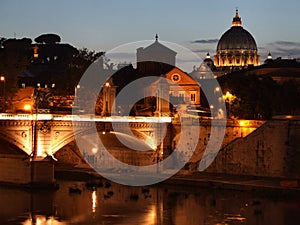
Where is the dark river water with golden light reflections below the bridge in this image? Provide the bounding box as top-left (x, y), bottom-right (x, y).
top-left (0, 181), bottom-right (300, 225)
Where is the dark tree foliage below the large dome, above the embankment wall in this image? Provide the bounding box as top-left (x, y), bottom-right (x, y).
top-left (219, 73), bottom-right (300, 119)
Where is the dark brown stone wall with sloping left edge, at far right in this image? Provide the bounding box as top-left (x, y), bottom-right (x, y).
top-left (206, 120), bottom-right (300, 178)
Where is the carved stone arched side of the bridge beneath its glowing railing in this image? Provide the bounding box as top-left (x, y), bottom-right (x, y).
top-left (0, 118), bottom-right (172, 160)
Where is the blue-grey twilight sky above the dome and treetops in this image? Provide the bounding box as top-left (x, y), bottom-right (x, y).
top-left (0, 0), bottom-right (300, 61)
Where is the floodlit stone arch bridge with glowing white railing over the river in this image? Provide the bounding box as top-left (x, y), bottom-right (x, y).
top-left (0, 114), bottom-right (171, 157)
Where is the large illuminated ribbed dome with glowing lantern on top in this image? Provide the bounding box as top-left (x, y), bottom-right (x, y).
top-left (214, 10), bottom-right (260, 67)
